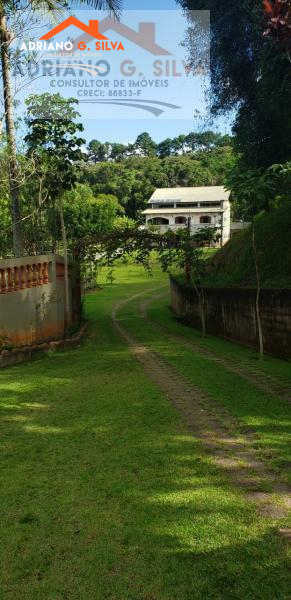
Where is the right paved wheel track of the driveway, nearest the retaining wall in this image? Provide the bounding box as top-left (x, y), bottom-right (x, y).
top-left (140, 293), bottom-right (291, 403)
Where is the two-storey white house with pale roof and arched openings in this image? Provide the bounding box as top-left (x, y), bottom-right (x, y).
top-left (142, 186), bottom-right (230, 245)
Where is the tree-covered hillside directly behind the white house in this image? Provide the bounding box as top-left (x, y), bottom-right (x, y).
top-left (79, 131), bottom-right (235, 219)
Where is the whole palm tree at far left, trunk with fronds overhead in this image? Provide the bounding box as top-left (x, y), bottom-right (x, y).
top-left (0, 0), bottom-right (120, 256)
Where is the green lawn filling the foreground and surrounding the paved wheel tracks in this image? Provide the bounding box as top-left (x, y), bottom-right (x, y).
top-left (0, 265), bottom-right (291, 600)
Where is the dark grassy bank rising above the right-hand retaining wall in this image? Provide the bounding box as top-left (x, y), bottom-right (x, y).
top-left (205, 203), bottom-right (291, 288)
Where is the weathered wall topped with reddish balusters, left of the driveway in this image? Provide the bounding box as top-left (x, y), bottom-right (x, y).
top-left (0, 254), bottom-right (72, 348)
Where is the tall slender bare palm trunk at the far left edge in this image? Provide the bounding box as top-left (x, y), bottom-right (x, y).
top-left (0, 8), bottom-right (23, 256)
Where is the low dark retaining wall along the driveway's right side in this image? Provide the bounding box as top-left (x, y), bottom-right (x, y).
top-left (171, 279), bottom-right (291, 359)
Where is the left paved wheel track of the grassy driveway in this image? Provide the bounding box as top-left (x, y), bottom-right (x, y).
top-left (112, 289), bottom-right (291, 538)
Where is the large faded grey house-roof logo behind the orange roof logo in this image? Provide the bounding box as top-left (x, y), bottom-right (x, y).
top-left (65, 17), bottom-right (172, 56)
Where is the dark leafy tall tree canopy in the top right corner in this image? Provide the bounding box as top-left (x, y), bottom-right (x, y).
top-left (179, 0), bottom-right (291, 167)
